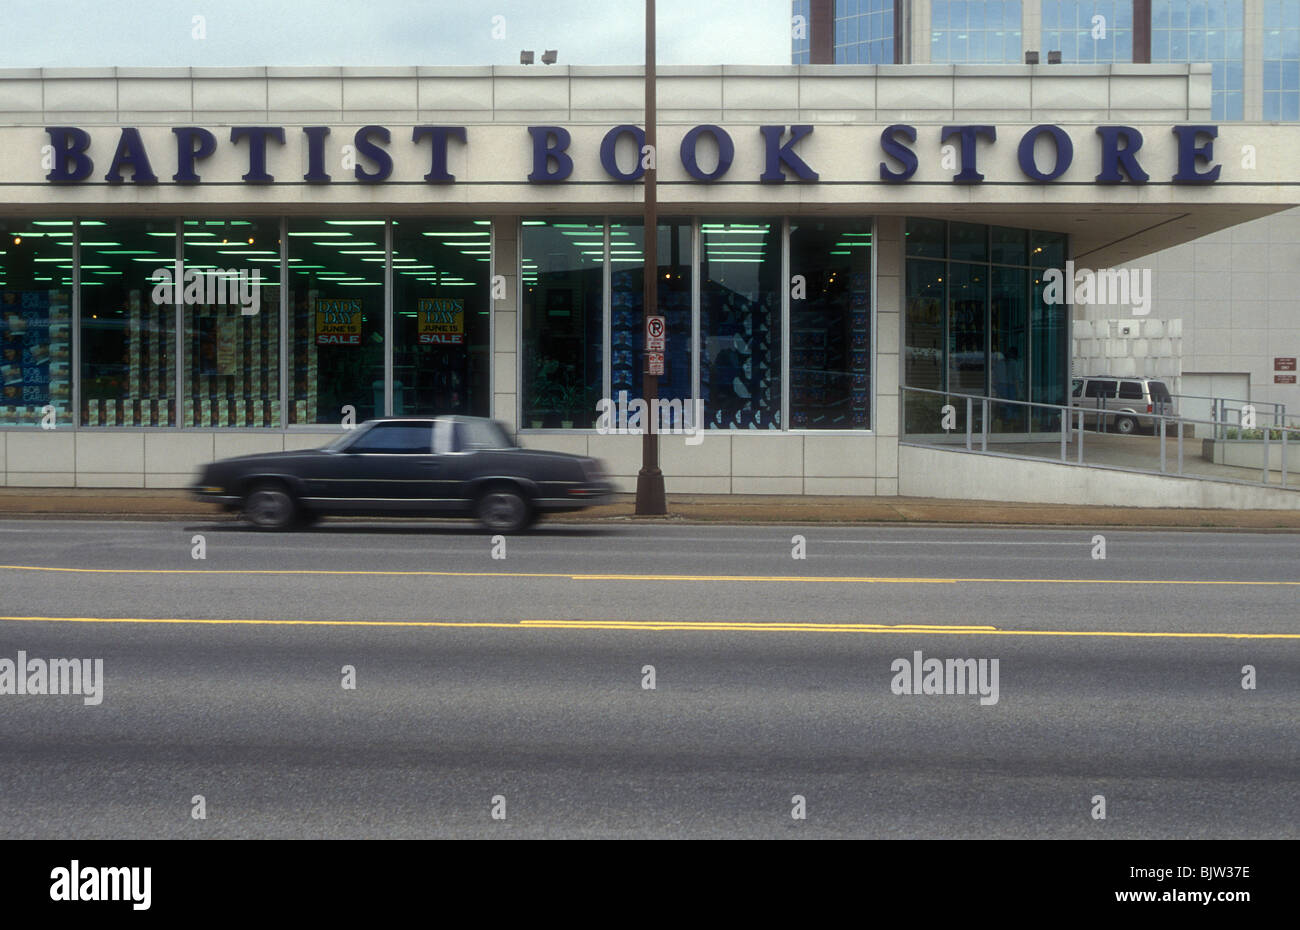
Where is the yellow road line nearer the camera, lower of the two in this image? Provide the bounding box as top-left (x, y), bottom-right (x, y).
top-left (0, 617), bottom-right (1300, 640)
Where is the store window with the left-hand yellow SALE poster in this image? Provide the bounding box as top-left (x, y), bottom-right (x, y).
top-left (286, 219), bottom-right (386, 425)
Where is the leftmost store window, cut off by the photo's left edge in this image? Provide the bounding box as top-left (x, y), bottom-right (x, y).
top-left (0, 220), bottom-right (73, 427)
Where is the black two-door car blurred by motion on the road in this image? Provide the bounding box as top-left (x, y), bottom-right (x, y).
top-left (190, 416), bottom-right (614, 533)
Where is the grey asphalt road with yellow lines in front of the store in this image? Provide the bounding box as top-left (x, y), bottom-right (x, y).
top-left (0, 520), bottom-right (1300, 838)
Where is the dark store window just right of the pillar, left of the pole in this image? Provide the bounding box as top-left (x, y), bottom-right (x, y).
top-left (520, 217), bottom-right (605, 429)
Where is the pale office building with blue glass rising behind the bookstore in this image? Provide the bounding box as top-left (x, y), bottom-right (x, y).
top-left (792, 0), bottom-right (1300, 418)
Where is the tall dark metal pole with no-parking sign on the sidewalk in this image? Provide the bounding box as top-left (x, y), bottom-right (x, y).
top-left (637, 0), bottom-right (668, 515)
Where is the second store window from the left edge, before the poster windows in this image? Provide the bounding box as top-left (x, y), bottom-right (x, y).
top-left (79, 219), bottom-right (178, 427)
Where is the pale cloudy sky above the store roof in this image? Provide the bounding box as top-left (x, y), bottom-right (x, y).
top-left (0, 0), bottom-right (790, 68)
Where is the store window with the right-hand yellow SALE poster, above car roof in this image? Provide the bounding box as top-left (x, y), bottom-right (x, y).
top-left (393, 220), bottom-right (491, 416)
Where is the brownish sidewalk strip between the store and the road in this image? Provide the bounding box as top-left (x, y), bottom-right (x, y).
top-left (0, 488), bottom-right (1300, 532)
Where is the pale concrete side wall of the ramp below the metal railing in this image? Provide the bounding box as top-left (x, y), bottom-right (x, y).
top-left (898, 442), bottom-right (1300, 510)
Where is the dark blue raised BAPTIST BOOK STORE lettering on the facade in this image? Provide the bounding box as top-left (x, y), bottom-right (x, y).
top-left (43, 124), bottom-right (1221, 185)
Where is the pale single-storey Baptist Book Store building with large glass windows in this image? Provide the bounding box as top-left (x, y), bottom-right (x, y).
top-left (0, 65), bottom-right (1300, 496)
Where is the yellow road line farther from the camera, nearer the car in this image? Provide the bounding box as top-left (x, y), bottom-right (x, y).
top-left (0, 565), bottom-right (1300, 588)
